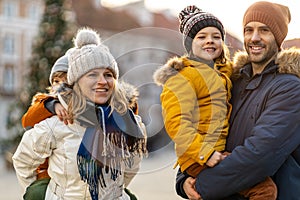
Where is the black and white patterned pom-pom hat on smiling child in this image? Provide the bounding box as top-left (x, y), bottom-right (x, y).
top-left (178, 5), bottom-right (225, 52)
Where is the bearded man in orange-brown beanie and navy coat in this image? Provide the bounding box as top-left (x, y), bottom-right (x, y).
top-left (176, 1), bottom-right (300, 200)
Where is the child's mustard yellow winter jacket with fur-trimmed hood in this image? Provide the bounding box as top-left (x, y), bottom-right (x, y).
top-left (153, 57), bottom-right (232, 171)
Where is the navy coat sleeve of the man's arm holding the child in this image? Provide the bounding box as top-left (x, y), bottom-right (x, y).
top-left (196, 79), bottom-right (300, 199)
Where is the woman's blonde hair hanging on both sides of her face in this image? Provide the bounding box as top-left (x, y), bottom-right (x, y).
top-left (68, 77), bottom-right (128, 119)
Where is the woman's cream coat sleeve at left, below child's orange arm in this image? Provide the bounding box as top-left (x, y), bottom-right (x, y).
top-left (12, 118), bottom-right (55, 189)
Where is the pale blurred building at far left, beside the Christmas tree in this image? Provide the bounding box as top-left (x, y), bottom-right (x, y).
top-left (0, 0), bottom-right (44, 139)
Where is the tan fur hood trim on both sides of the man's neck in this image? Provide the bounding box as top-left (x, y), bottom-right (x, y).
top-left (233, 48), bottom-right (300, 78)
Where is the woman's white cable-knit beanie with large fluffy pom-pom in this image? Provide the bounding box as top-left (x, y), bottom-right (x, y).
top-left (68, 28), bottom-right (119, 85)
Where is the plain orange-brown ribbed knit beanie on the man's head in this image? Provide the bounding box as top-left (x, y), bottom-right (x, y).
top-left (243, 1), bottom-right (291, 47)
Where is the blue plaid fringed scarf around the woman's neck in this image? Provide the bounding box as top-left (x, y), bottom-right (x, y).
top-left (77, 104), bottom-right (146, 200)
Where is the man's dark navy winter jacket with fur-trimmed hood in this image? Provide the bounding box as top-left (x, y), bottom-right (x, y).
top-left (176, 50), bottom-right (300, 200)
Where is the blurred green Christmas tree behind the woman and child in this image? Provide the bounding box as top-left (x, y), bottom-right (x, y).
top-left (7, 0), bottom-right (76, 147)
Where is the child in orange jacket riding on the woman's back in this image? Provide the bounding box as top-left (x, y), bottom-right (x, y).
top-left (22, 52), bottom-right (72, 200)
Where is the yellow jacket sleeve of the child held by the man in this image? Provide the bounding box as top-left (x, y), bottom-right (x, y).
top-left (161, 67), bottom-right (218, 171)
